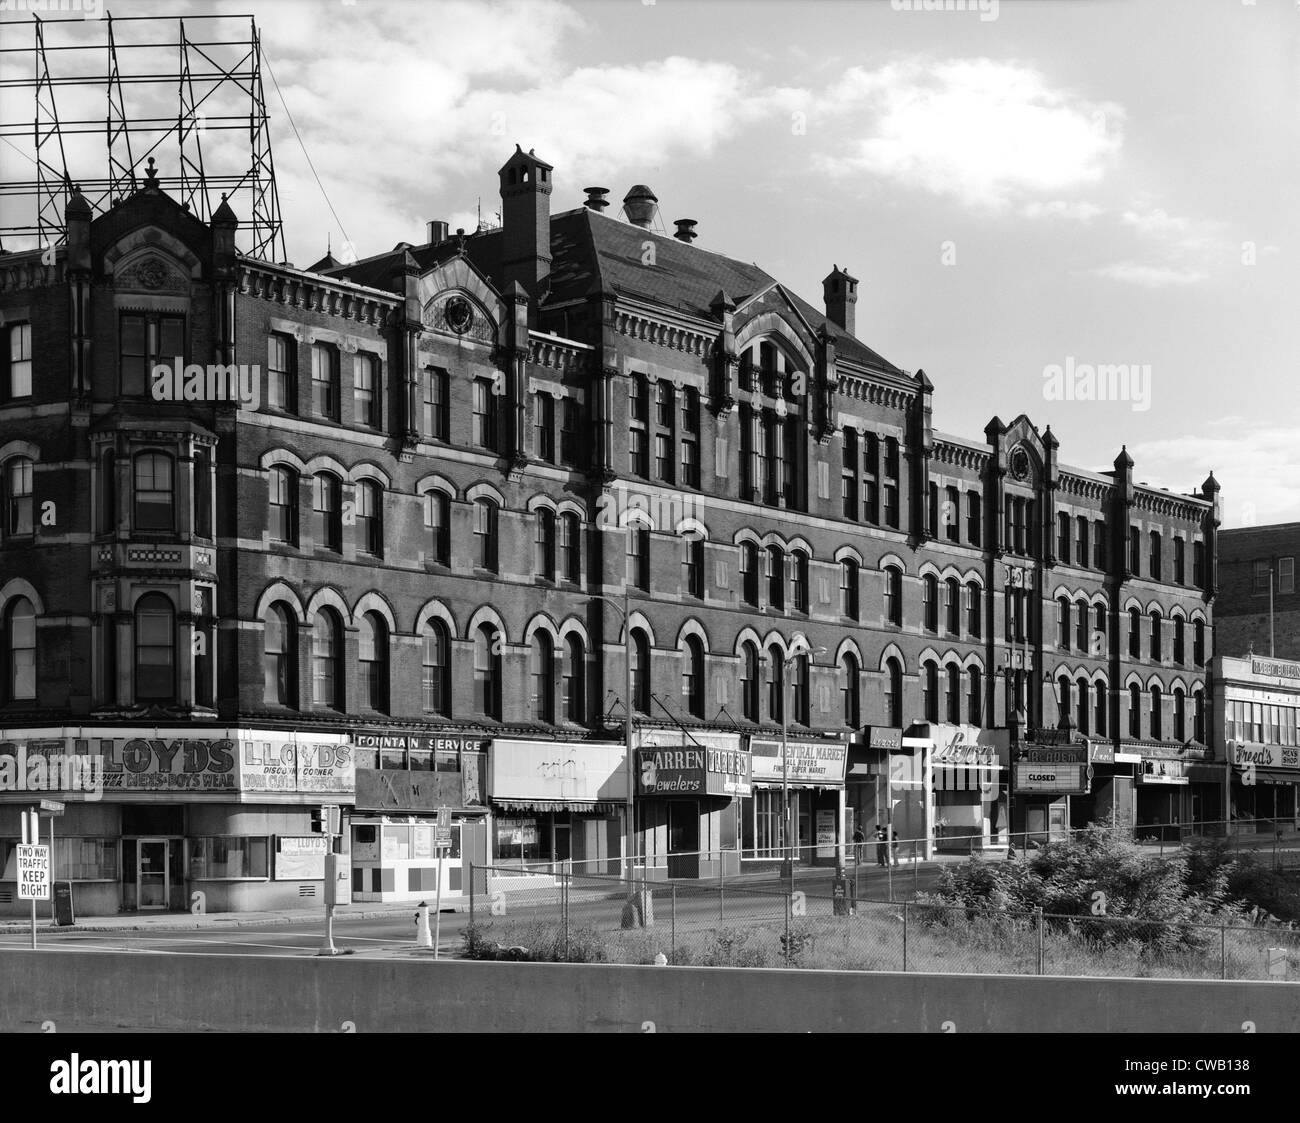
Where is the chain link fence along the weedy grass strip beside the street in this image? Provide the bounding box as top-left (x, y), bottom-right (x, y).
top-left (465, 867), bottom-right (1300, 981)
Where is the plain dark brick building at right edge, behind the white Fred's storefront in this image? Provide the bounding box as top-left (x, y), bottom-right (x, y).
top-left (1214, 523), bottom-right (1300, 659)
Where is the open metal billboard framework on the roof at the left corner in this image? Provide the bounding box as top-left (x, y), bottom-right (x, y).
top-left (0, 14), bottom-right (286, 261)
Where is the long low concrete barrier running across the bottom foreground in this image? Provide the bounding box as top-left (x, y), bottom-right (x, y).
top-left (0, 950), bottom-right (1300, 1033)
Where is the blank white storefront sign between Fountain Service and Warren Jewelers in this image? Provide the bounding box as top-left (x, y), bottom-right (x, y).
top-left (488, 737), bottom-right (628, 803)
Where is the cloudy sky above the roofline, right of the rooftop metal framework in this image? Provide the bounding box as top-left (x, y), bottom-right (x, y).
top-left (0, 0), bottom-right (1300, 526)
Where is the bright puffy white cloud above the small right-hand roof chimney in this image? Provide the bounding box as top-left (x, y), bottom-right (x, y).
top-left (819, 57), bottom-right (1125, 208)
